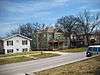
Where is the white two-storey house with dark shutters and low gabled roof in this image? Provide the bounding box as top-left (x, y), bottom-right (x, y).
top-left (2, 34), bottom-right (32, 54)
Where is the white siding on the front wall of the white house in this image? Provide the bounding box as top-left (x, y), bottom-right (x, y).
top-left (4, 36), bottom-right (30, 54)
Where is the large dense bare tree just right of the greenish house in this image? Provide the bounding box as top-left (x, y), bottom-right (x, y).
top-left (56, 15), bottom-right (77, 48)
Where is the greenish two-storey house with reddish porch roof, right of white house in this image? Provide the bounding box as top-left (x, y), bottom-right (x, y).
top-left (37, 28), bottom-right (64, 50)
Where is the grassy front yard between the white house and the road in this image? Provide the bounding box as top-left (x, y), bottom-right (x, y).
top-left (0, 51), bottom-right (59, 65)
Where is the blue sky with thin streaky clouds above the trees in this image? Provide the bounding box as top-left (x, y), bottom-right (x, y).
top-left (0, 0), bottom-right (100, 36)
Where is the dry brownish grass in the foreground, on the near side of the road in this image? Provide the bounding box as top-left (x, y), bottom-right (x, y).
top-left (35, 56), bottom-right (100, 75)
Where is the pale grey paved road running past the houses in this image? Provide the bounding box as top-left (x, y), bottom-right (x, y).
top-left (0, 52), bottom-right (87, 75)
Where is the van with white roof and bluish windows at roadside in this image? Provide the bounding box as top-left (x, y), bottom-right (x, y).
top-left (86, 45), bottom-right (100, 57)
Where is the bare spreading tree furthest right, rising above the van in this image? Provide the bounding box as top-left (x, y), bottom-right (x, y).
top-left (78, 10), bottom-right (100, 45)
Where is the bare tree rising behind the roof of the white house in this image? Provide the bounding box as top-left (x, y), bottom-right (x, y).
top-left (7, 23), bottom-right (34, 38)
